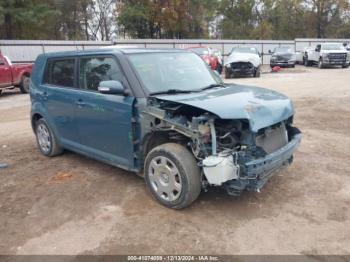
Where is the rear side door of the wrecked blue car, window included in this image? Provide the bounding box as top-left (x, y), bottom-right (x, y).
top-left (38, 57), bottom-right (79, 146)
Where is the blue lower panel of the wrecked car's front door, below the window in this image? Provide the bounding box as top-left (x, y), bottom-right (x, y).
top-left (74, 90), bottom-right (134, 169)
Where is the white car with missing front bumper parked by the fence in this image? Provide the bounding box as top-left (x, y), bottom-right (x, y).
top-left (225, 47), bottom-right (262, 78)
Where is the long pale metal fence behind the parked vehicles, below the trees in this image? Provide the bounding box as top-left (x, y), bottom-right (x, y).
top-left (0, 38), bottom-right (350, 64)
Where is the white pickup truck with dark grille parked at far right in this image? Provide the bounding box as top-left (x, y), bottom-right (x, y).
top-left (305, 43), bottom-right (350, 68)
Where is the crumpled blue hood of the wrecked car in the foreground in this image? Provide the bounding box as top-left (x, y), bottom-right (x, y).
top-left (156, 85), bottom-right (294, 132)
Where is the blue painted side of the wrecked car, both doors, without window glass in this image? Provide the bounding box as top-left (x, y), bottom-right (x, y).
top-left (30, 54), bottom-right (139, 171)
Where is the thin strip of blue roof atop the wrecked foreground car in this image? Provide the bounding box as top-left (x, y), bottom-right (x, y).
top-left (45, 46), bottom-right (188, 57)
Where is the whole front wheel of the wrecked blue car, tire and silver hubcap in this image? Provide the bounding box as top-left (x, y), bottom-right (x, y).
top-left (144, 143), bottom-right (201, 209)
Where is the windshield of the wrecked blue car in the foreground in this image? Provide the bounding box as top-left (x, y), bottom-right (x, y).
top-left (129, 52), bottom-right (221, 93)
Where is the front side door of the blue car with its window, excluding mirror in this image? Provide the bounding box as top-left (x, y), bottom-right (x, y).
top-left (76, 56), bottom-right (134, 169)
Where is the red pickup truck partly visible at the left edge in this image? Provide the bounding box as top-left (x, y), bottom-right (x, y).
top-left (0, 53), bottom-right (33, 94)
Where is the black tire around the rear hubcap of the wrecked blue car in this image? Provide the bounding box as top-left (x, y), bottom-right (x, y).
top-left (35, 118), bottom-right (63, 157)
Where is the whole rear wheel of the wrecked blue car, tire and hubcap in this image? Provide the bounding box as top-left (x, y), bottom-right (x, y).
top-left (35, 118), bottom-right (63, 157)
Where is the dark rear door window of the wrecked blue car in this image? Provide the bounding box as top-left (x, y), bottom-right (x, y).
top-left (44, 58), bottom-right (75, 87)
